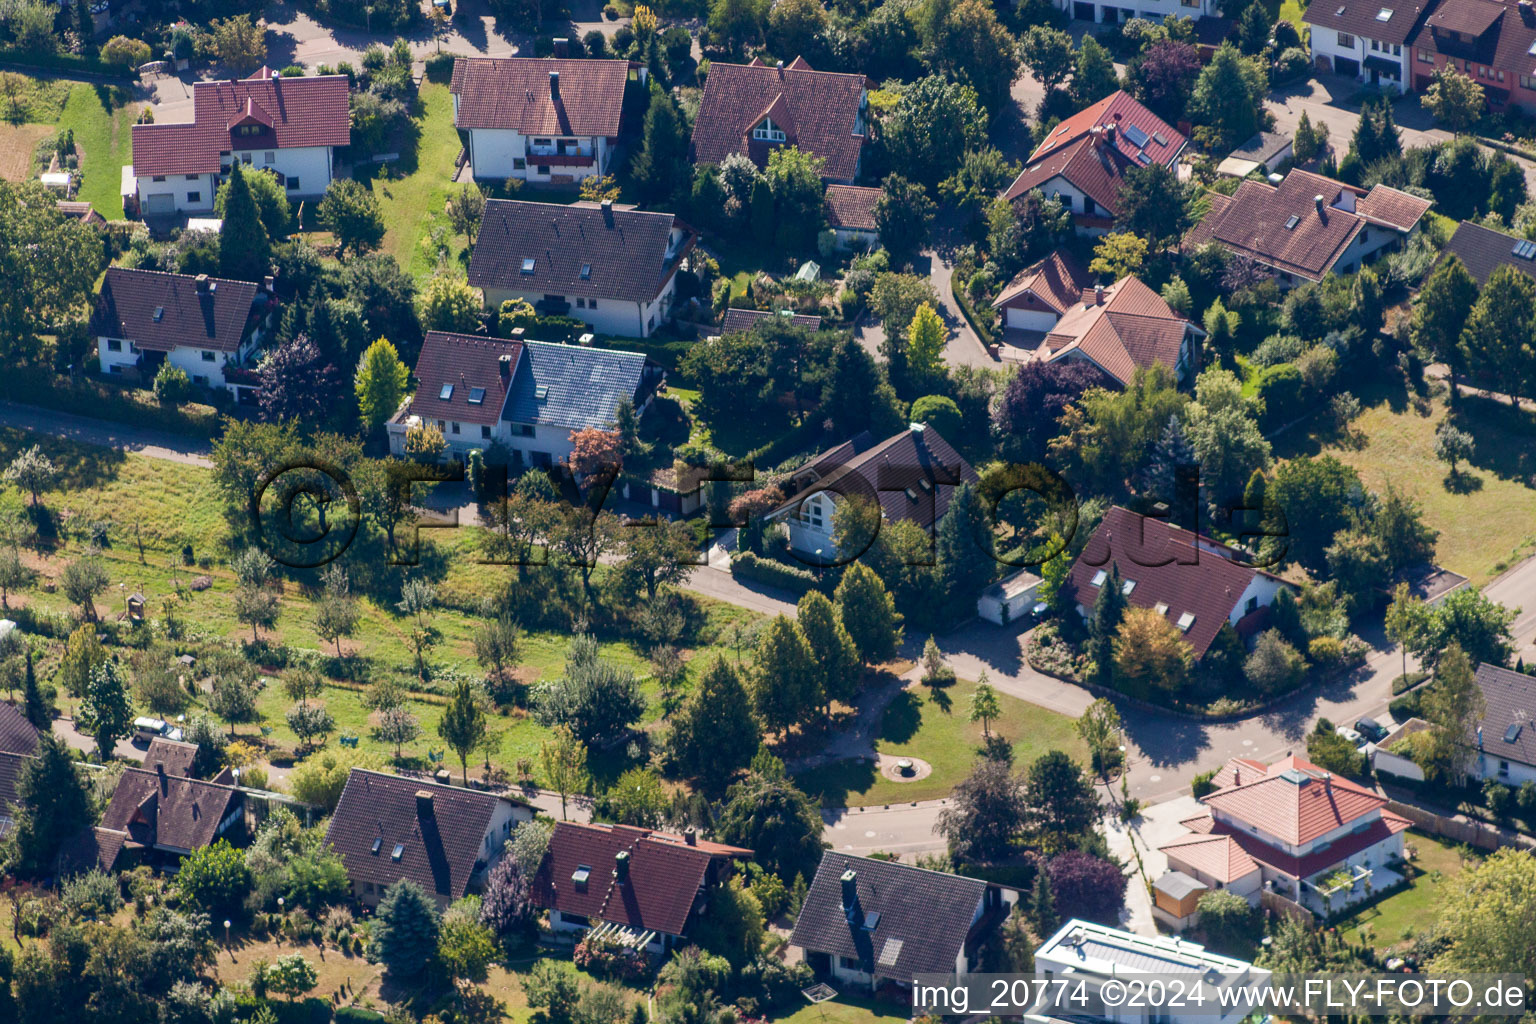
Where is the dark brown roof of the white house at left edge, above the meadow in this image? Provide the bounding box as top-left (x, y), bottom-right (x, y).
top-left (94, 267), bottom-right (264, 352)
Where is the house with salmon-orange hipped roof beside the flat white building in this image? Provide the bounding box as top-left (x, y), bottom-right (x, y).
top-left (1158, 755), bottom-right (1409, 924)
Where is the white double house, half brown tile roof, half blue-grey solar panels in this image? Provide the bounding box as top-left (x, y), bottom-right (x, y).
top-left (386, 330), bottom-right (662, 468)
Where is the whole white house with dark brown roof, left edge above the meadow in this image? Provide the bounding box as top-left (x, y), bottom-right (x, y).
top-left (92, 267), bottom-right (276, 404)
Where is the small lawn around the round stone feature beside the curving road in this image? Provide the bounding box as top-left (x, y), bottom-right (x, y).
top-left (796, 680), bottom-right (1087, 808)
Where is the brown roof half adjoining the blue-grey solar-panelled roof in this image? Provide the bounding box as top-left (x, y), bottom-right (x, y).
top-left (410, 330), bottom-right (522, 427)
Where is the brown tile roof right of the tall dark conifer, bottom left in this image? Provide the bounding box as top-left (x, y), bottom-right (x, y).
top-left (101, 768), bottom-right (244, 851)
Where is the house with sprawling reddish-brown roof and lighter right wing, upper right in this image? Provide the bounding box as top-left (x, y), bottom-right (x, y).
top-left (1183, 170), bottom-right (1433, 286)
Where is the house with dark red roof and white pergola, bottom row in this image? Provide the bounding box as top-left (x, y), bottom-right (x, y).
top-left (531, 821), bottom-right (753, 953)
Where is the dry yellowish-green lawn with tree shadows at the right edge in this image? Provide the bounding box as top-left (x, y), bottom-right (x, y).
top-left (1275, 384), bottom-right (1536, 585)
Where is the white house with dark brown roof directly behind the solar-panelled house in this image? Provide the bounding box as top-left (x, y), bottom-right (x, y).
top-left (468, 200), bottom-right (699, 338)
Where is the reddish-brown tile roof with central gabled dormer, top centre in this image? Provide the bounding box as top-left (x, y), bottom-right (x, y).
top-left (690, 58), bottom-right (865, 181)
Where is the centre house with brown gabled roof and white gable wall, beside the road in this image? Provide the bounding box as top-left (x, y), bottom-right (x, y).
top-left (765, 424), bottom-right (980, 563)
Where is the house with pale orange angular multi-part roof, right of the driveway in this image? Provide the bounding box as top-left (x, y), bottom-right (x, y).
top-left (992, 252), bottom-right (1206, 387)
